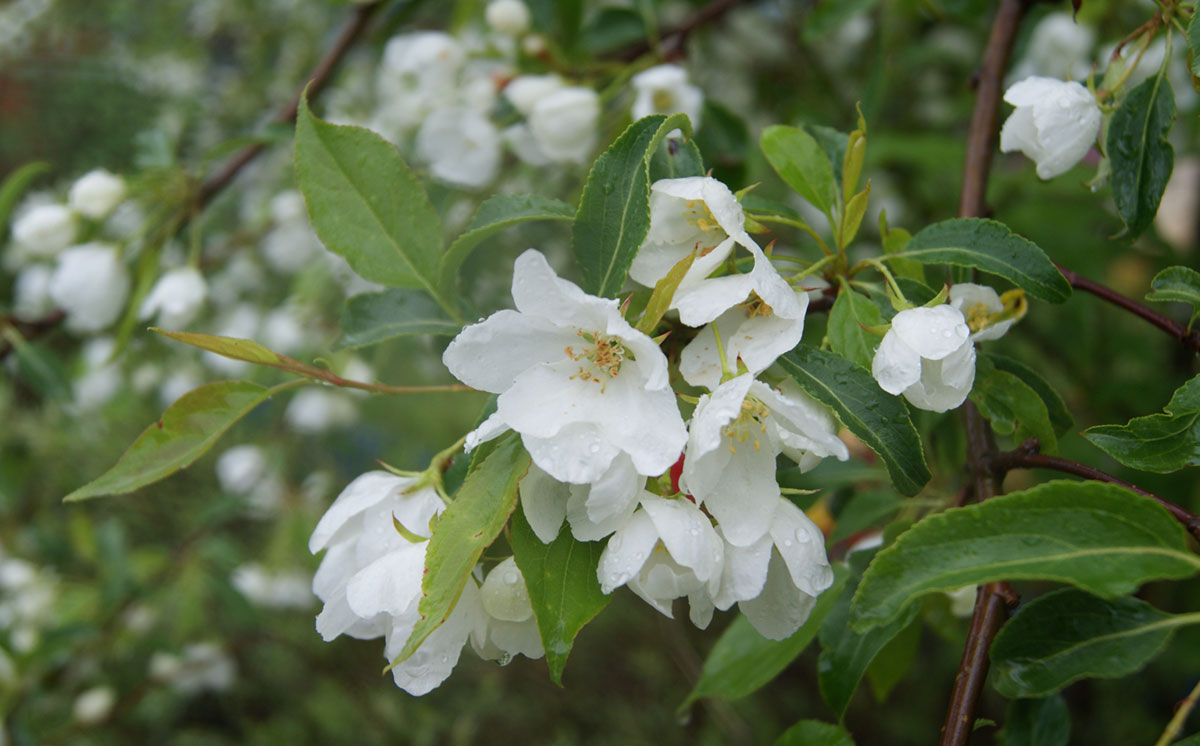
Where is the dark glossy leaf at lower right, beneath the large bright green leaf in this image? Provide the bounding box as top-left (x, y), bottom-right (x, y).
top-left (991, 588), bottom-right (1200, 697)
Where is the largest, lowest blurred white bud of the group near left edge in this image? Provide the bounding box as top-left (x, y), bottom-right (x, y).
top-left (50, 243), bottom-right (130, 333)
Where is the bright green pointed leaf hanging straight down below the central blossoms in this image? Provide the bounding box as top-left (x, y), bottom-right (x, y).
top-left (511, 510), bottom-right (611, 686)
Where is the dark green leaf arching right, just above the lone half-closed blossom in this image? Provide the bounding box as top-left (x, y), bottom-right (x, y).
top-left (887, 217), bottom-right (1070, 303)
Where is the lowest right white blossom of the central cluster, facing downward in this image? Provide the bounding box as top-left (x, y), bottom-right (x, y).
top-left (714, 498), bottom-right (833, 639)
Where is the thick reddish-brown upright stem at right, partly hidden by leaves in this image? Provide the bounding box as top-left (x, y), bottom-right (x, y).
top-left (941, 0), bottom-right (1030, 746)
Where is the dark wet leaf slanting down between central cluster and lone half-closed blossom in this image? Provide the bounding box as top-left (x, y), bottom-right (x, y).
top-left (779, 344), bottom-right (930, 495)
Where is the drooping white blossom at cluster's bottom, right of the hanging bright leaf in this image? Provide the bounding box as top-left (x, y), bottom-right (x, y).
top-left (596, 492), bottom-right (725, 628)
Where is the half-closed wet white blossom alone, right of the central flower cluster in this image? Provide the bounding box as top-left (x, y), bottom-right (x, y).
top-left (871, 306), bottom-right (976, 411)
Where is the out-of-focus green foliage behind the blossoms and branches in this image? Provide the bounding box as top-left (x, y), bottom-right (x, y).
top-left (0, 0), bottom-right (1200, 746)
